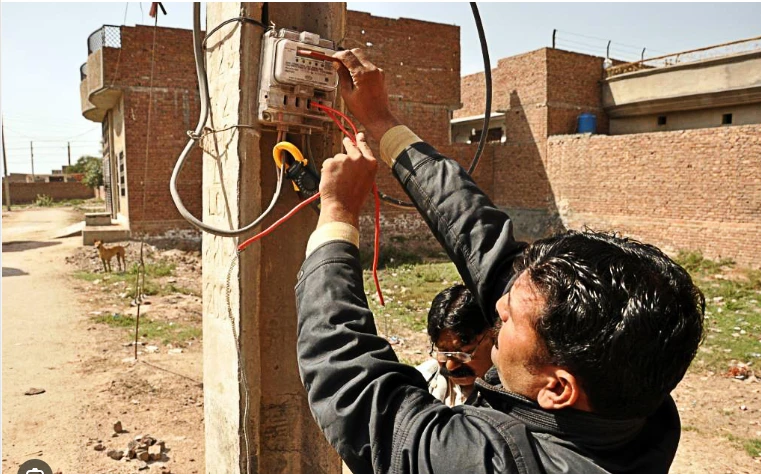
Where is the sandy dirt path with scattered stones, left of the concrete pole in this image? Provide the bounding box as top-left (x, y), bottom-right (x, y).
top-left (2, 209), bottom-right (204, 474)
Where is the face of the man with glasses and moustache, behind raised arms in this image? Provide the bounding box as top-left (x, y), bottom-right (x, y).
top-left (435, 329), bottom-right (494, 386)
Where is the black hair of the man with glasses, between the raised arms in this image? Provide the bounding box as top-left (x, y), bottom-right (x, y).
top-left (428, 284), bottom-right (494, 346)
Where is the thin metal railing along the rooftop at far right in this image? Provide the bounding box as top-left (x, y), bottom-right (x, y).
top-left (605, 36), bottom-right (761, 77)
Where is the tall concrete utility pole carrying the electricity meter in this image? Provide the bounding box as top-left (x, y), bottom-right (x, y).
top-left (202, 3), bottom-right (346, 474)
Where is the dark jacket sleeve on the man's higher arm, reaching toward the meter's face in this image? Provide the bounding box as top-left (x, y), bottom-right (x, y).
top-left (393, 142), bottom-right (525, 315)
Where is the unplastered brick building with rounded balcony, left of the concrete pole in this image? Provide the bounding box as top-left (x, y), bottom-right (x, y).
top-left (80, 26), bottom-right (202, 235)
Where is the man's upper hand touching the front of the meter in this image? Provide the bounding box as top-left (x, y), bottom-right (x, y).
top-left (333, 49), bottom-right (400, 140)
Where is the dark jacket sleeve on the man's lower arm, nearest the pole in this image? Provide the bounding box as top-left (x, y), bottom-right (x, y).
top-left (296, 241), bottom-right (515, 474)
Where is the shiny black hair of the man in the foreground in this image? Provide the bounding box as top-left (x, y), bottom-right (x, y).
top-left (508, 231), bottom-right (705, 418)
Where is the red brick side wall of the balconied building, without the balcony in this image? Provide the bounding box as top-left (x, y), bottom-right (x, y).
top-left (104, 26), bottom-right (202, 234)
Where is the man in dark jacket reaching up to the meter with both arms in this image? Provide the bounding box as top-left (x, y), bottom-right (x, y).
top-left (296, 50), bottom-right (705, 474)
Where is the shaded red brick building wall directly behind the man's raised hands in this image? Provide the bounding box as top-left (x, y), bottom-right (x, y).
top-left (341, 11), bottom-right (464, 247)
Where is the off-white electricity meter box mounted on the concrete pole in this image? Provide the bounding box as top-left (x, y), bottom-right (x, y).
top-left (258, 29), bottom-right (338, 133)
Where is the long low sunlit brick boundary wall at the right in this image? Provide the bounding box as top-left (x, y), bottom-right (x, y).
top-left (548, 125), bottom-right (761, 267)
